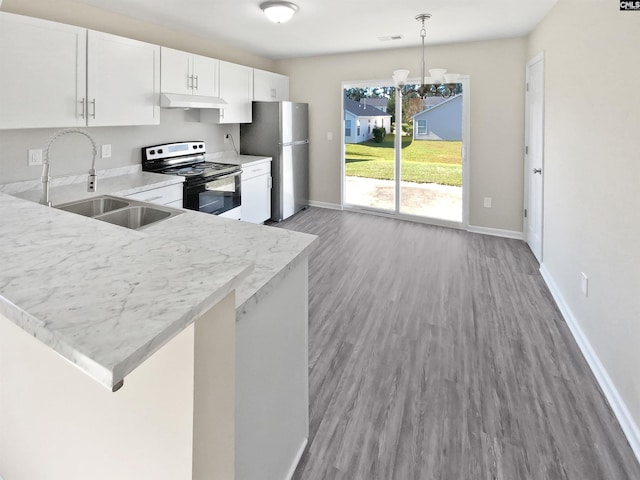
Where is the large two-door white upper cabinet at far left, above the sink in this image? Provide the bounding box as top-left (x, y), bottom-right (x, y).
top-left (0, 13), bottom-right (160, 129)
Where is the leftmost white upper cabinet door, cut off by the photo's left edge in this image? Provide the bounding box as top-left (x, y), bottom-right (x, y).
top-left (0, 12), bottom-right (87, 128)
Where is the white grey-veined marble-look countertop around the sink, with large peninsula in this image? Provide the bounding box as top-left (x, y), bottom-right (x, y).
top-left (0, 165), bottom-right (317, 388)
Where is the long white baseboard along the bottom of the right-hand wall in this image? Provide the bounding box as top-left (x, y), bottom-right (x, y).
top-left (540, 263), bottom-right (640, 461)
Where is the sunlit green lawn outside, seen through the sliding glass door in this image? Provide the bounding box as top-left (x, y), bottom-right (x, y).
top-left (345, 135), bottom-right (462, 187)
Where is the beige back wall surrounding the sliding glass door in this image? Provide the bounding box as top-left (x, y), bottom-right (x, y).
top-left (277, 38), bottom-right (527, 232)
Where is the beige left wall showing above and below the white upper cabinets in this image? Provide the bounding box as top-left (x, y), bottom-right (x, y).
top-left (0, 0), bottom-right (274, 184)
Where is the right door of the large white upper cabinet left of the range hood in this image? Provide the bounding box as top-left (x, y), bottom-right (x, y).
top-left (87, 30), bottom-right (160, 126)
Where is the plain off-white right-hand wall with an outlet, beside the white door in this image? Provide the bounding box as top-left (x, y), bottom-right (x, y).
top-left (528, 0), bottom-right (640, 442)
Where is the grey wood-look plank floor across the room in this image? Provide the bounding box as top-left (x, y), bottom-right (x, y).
top-left (279, 208), bottom-right (640, 480)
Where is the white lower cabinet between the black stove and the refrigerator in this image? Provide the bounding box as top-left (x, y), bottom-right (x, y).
top-left (240, 158), bottom-right (271, 223)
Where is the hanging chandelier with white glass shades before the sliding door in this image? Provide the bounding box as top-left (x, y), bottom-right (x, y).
top-left (393, 13), bottom-right (460, 98)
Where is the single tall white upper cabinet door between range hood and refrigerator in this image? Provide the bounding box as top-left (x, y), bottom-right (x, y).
top-left (220, 61), bottom-right (253, 123)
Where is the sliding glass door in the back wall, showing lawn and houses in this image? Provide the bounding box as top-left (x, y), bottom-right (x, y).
top-left (343, 79), bottom-right (465, 224)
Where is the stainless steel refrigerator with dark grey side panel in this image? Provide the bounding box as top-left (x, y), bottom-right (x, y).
top-left (240, 102), bottom-right (309, 222)
